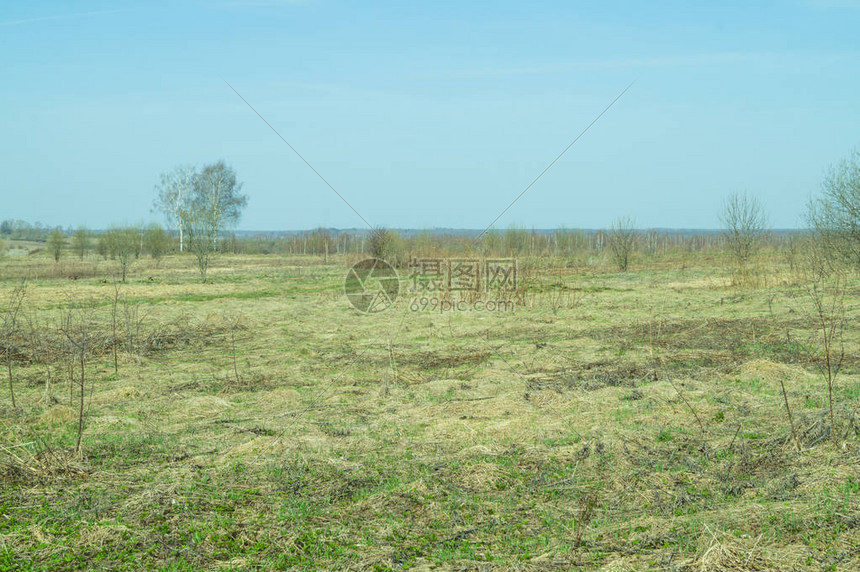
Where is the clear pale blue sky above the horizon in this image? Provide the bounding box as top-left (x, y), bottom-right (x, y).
top-left (0, 0), bottom-right (860, 230)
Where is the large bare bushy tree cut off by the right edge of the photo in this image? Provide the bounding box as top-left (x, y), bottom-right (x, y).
top-left (806, 149), bottom-right (860, 266)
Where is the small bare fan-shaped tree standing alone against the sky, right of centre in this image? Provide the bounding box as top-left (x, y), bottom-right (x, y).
top-left (720, 193), bottom-right (767, 274)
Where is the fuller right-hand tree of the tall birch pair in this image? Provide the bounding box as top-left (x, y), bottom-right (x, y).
top-left (182, 161), bottom-right (248, 282)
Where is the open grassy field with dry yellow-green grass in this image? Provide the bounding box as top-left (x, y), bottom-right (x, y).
top-left (0, 251), bottom-right (860, 571)
